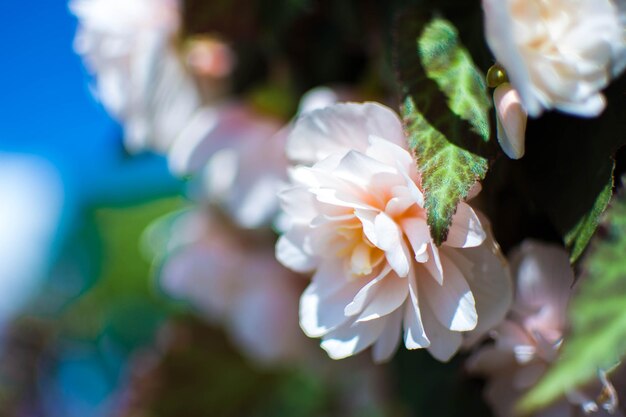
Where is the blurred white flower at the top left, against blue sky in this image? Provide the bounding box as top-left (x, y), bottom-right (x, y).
top-left (70, 0), bottom-right (211, 152)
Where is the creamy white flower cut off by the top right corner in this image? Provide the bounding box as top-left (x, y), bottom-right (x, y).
top-left (483, 0), bottom-right (626, 117)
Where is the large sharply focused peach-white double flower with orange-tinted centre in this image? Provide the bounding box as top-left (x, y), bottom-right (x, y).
top-left (276, 103), bottom-right (511, 361)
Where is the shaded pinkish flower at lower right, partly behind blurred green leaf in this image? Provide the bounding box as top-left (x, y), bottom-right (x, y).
top-left (468, 240), bottom-right (619, 417)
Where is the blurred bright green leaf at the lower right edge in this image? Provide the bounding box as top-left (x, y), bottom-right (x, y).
top-left (521, 180), bottom-right (626, 411)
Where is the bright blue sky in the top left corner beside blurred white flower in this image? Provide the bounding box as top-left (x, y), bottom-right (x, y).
top-left (0, 0), bottom-right (177, 205)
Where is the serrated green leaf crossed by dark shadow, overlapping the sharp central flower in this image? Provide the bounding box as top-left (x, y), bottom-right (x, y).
top-left (395, 15), bottom-right (492, 244)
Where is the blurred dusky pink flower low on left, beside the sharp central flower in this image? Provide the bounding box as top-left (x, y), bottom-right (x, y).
top-left (145, 210), bottom-right (307, 364)
